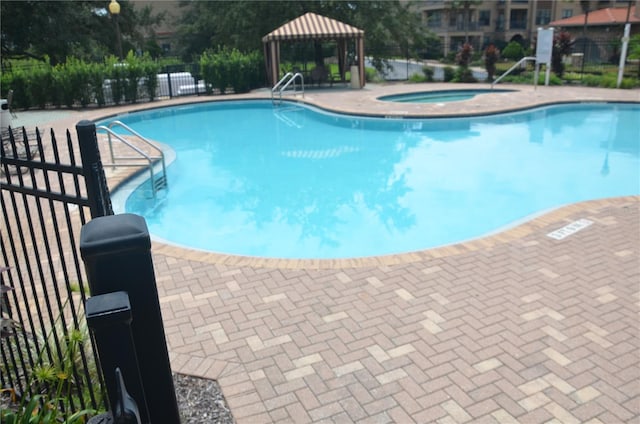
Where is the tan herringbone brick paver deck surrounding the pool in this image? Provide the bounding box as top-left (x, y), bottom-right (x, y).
top-left (23, 85), bottom-right (640, 423)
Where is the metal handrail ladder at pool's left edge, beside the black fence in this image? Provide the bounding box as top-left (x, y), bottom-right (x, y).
top-left (96, 121), bottom-right (168, 199)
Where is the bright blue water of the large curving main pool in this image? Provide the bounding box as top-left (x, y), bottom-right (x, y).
top-left (107, 101), bottom-right (640, 258)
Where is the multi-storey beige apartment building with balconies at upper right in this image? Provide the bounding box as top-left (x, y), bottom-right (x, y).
top-left (419, 0), bottom-right (629, 55)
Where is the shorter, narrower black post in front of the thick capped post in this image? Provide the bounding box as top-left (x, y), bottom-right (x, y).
top-left (85, 291), bottom-right (149, 424)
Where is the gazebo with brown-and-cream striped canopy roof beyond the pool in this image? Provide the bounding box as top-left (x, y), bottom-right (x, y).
top-left (262, 12), bottom-right (365, 88)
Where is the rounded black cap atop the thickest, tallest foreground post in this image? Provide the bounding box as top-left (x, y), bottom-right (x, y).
top-left (80, 213), bottom-right (151, 259)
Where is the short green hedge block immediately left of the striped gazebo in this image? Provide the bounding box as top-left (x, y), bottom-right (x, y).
top-left (200, 49), bottom-right (266, 94)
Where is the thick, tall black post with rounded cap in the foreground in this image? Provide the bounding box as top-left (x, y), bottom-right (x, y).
top-left (80, 214), bottom-right (180, 424)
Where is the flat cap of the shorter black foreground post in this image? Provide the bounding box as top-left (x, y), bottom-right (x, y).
top-left (84, 291), bottom-right (132, 330)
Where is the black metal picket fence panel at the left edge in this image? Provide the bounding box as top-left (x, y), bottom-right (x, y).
top-left (0, 124), bottom-right (113, 411)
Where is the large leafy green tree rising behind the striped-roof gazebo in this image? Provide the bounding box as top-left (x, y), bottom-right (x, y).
top-left (177, 0), bottom-right (428, 70)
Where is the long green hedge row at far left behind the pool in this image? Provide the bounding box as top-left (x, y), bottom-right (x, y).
top-left (1, 52), bottom-right (160, 109)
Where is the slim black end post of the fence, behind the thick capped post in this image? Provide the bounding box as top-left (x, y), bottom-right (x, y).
top-left (76, 120), bottom-right (113, 218)
